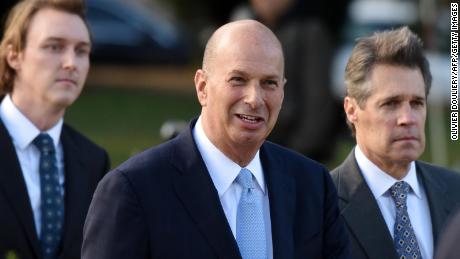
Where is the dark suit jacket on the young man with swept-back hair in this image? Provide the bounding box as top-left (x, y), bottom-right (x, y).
top-left (0, 120), bottom-right (109, 259)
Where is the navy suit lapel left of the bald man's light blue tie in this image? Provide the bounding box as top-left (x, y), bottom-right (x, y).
top-left (170, 121), bottom-right (241, 258)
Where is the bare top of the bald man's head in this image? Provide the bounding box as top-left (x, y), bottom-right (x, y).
top-left (203, 20), bottom-right (284, 72)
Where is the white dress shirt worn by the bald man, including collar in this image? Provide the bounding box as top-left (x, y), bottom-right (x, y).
top-left (193, 117), bottom-right (273, 258)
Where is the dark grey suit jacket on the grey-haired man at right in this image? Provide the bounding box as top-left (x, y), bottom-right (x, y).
top-left (331, 150), bottom-right (460, 259)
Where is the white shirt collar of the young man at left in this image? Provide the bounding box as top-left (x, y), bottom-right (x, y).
top-left (0, 94), bottom-right (64, 149)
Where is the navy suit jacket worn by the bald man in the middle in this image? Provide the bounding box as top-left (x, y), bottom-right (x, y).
top-left (82, 120), bottom-right (348, 259)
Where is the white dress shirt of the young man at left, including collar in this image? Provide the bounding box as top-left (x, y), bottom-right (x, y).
top-left (0, 95), bottom-right (64, 237)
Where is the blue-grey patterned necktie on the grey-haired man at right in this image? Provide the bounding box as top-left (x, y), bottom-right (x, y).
top-left (390, 181), bottom-right (422, 259)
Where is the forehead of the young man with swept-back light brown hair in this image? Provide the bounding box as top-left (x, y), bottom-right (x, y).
top-left (27, 8), bottom-right (90, 43)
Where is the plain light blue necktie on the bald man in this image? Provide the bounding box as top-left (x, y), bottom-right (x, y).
top-left (236, 168), bottom-right (267, 259)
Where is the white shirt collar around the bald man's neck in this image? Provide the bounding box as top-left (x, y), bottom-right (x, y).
top-left (193, 116), bottom-right (265, 197)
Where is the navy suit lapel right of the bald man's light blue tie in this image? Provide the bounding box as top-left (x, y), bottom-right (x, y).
top-left (260, 145), bottom-right (296, 258)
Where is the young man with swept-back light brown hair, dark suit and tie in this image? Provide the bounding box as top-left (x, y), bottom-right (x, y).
top-left (0, 0), bottom-right (109, 259)
